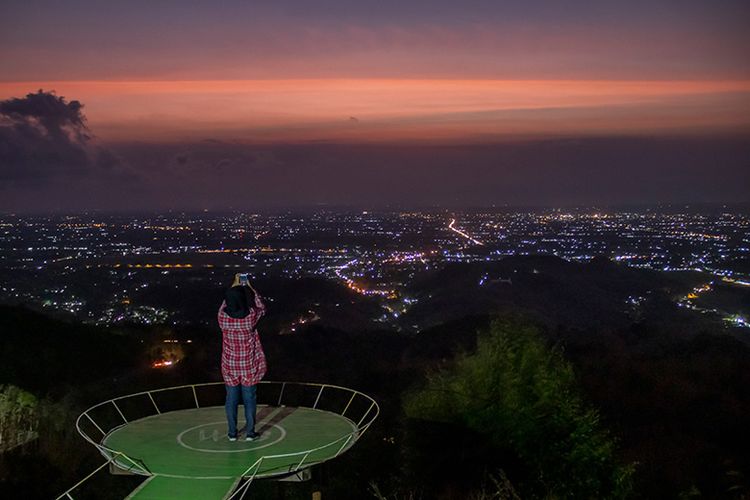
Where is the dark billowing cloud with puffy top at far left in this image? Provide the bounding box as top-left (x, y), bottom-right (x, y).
top-left (0, 89), bottom-right (132, 184)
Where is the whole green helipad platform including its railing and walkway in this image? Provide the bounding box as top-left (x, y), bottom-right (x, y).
top-left (58, 381), bottom-right (380, 500)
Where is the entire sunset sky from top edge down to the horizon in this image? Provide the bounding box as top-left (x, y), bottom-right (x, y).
top-left (0, 0), bottom-right (750, 210)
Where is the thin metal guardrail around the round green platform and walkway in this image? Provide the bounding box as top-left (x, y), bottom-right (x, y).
top-left (57, 381), bottom-right (380, 500)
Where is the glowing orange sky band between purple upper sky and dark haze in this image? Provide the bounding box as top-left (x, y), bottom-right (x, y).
top-left (0, 79), bottom-right (750, 143)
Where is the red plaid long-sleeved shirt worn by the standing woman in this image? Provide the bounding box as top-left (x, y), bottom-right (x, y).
top-left (218, 294), bottom-right (266, 385)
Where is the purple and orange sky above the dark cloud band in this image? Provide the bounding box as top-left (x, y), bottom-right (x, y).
top-left (0, 0), bottom-right (750, 143)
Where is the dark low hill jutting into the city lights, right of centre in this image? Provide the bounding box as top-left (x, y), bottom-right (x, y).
top-left (402, 256), bottom-right (705, 328)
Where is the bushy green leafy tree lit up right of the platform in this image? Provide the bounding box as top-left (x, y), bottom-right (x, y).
top-left (404, 316), bottom-right (633, 498)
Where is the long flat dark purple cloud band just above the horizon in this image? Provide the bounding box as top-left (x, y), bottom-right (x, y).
top-left (97, 136), bottom-right (750, 209)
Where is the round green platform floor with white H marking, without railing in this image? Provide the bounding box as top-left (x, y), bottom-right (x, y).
top-left (101, 405), bottom-right (358, 479)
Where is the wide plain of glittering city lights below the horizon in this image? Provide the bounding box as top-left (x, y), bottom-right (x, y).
top-left (0, 209), bottom-right (750, 328)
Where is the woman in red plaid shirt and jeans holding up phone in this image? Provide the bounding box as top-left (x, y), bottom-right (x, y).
top-left (218, 274), bottom-right (266, 441)
